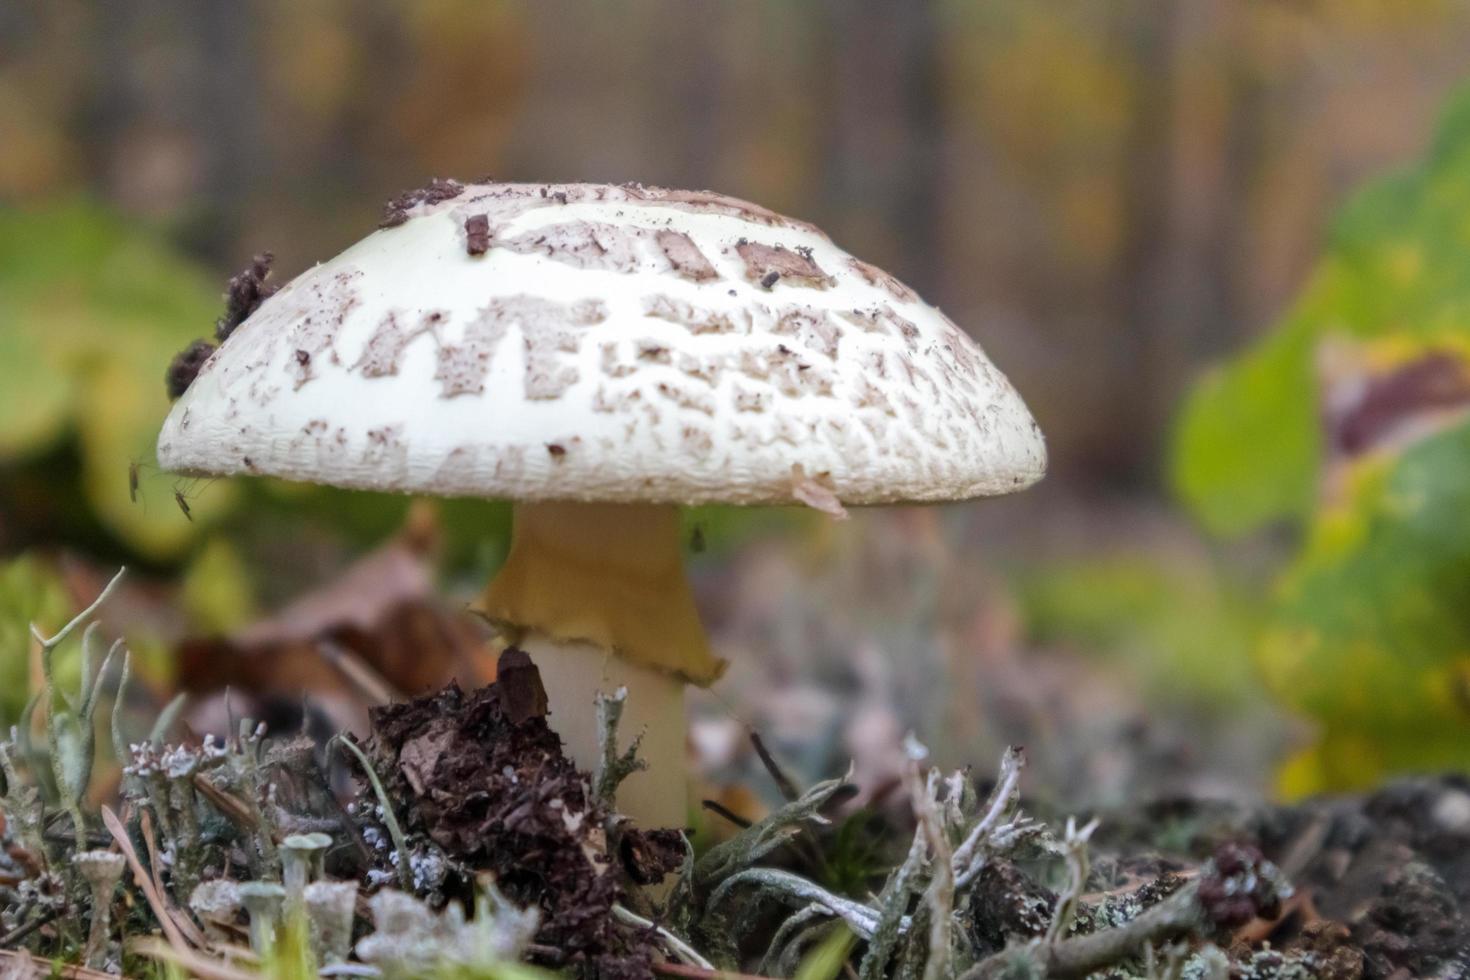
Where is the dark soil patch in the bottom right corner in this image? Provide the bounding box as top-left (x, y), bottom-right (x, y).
top-left (1098, 776), bottom-right (1470, 980)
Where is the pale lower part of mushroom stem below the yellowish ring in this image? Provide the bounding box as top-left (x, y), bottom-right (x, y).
top-left (516, 630), bottom-right (689, 829)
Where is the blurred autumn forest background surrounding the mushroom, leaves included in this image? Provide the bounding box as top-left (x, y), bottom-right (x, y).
top-left (0, 0), bottom-right (1470, 822)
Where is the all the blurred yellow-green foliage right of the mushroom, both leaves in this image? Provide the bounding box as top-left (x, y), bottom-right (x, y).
top-left (1172, 82), bottom-right (1470, 795)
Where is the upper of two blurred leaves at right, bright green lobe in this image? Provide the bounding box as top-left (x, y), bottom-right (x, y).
top-left (1170, 90), bottom-right (1470, 535)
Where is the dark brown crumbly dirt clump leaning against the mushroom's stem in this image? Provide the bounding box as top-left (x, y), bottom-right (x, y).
top-left (370, 649), bottom-right (667, 979)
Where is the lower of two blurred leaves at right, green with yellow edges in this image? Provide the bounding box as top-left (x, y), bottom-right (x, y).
top-left (1260, 423), bottom-right (1470, 787)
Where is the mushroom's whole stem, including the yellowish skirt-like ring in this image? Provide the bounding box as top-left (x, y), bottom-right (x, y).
top-left (482, 502), bottom-right (725, 827)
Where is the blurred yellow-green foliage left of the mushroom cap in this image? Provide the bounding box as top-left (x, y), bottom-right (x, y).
top-left (0, 201), bottom-right (232, 558)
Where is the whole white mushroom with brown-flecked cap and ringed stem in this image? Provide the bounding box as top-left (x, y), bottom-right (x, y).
top-left (159, 182), bottom-right (1047, 826)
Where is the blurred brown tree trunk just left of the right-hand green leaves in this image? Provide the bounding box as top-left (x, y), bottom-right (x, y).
top-left (1089, 0), bottom-right (1264, 486)
